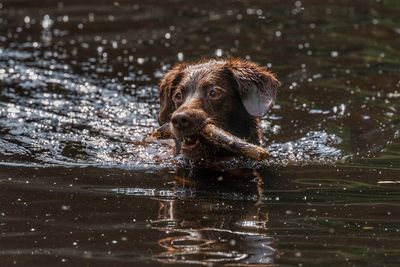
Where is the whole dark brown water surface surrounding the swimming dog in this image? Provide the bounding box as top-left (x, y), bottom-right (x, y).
top-left (0, 0), bottom-right (400, 266)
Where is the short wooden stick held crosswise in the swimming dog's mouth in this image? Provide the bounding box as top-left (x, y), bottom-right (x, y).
top-left (148, 123), bottom-right (269, 161)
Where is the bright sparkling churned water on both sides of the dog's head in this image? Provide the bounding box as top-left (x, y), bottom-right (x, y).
top-left (0, 50), bottom-right (341, 169)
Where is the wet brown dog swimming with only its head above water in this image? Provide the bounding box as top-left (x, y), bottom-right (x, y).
top-left (158, 59), bottom-right (280, 160)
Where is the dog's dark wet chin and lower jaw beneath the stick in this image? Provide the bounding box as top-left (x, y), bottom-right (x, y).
top-left (181, 135), bottom-right (212, 160)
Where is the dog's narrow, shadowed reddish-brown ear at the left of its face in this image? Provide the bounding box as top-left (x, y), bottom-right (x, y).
top-left (158, 63), bottom-right (186, 125)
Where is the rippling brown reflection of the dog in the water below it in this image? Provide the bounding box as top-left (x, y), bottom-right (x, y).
top-left (151, 169), bottom-right (276, 266)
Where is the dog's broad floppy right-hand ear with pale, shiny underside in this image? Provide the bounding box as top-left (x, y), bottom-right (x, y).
top-left (228, 59), bottom-right (280, 117)
